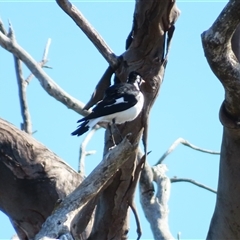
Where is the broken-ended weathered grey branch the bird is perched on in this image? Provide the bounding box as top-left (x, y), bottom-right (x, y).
top-left (35, 138), bottom-right (136, 240)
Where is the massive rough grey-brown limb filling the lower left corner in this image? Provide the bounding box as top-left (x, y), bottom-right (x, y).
top-left (0, 119), bottom-right (83, 239)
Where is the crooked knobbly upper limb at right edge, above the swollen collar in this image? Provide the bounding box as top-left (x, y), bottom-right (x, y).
top-left (202, 0), bottom-right (240, 117)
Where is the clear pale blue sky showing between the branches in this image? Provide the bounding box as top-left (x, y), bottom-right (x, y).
top-left (0, 0), bottom-right (226, 239)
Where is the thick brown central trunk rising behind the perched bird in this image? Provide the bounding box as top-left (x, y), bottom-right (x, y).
top-left (87, 0), bottom-right (179, 240)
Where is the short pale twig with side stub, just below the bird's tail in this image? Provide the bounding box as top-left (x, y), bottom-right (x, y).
top-left (78, 125), bottom-right (100, 175)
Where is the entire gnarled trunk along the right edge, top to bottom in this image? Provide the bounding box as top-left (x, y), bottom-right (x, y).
top-left (202, 0), bottom-right (240, 239)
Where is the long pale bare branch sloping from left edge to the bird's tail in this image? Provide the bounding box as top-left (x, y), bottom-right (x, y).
top-left (0, 25), bottom-right (88, 116)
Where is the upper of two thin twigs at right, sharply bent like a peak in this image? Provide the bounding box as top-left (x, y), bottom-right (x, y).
top-left (155, 138), bottom-right (220, 166)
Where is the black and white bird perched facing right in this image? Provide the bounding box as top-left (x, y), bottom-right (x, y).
top-left (72, 72), bottom-right (144, 136)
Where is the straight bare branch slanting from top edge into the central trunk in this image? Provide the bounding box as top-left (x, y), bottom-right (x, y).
top-left (56, 0), bottom-right (118, 69)
